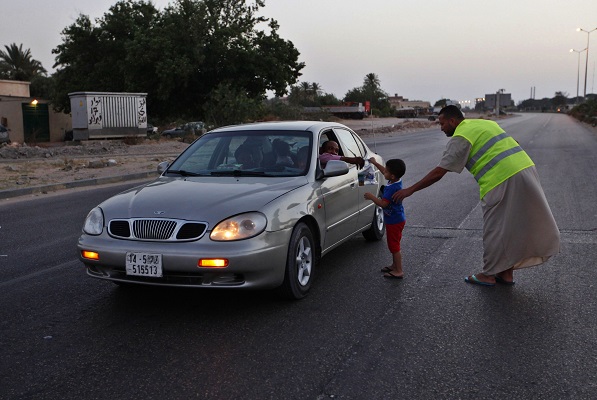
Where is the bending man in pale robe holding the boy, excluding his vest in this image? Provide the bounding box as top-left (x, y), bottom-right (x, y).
top-left (393, 106), bottom-right (560, 286)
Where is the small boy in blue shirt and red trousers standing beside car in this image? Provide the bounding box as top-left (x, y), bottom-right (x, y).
top-left (365, 158), bottom-right (406, 279)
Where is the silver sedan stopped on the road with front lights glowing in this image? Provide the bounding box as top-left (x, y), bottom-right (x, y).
top-left (78, 121), bottom-right (385, 299)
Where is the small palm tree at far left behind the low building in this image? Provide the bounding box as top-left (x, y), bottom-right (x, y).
top-left (0, 43), bottom-right (46, 81)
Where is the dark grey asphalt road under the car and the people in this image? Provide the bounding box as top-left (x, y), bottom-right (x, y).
top-left (0, 114), bottom-right (597, 400)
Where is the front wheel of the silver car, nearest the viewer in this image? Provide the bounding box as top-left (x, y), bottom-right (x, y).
top-left (279, 222), bottom-right (315, 300)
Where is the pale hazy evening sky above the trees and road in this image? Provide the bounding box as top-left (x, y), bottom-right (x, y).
top-left (0, 0), bottom-right (597, 105)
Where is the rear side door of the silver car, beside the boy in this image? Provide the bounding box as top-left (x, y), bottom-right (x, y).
top-left (334, 128), bottom-right (378, 230)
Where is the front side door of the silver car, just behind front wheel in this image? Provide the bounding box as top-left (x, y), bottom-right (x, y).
top-left (319, 131), bottom-right (359, 249)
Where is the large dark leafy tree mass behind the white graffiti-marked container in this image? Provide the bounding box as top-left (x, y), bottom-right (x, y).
top-left (53, 0), bottom-right (304, 123)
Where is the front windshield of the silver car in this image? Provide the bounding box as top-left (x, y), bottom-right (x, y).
top-left (166, 130), bottom-right (313, 177)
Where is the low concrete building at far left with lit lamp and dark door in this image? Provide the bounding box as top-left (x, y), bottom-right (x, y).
top-left (0, 80), bottom-right (72, 144)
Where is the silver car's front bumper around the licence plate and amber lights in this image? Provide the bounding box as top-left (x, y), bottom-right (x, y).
top-left (77, 229), bottom-right (292, 289)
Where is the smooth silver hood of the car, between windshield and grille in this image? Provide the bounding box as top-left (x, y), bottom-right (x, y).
top-left (100, 177), bottom-right (307, 226)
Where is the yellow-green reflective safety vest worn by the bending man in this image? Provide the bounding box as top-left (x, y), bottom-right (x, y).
top-left (454, 119), bottom-right (535, 199)
